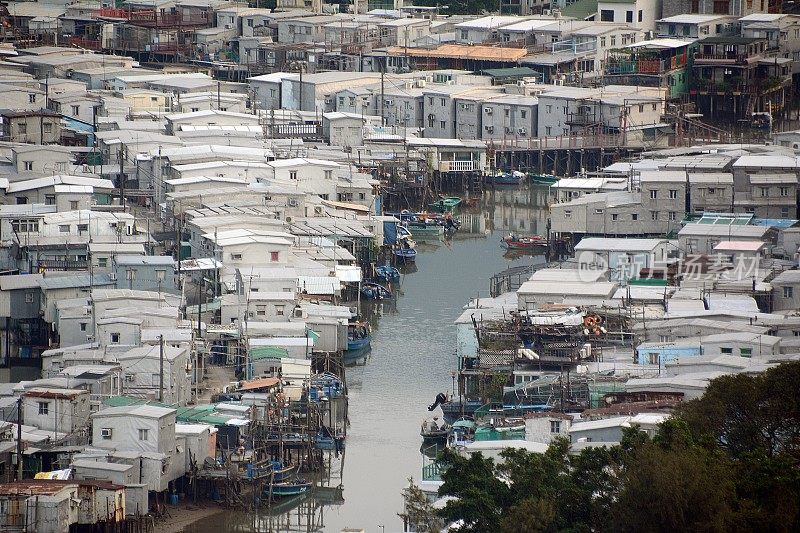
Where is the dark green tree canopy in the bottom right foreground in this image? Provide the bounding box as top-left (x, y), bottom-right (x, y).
top-left (438, 362), bottom-right (800, 533)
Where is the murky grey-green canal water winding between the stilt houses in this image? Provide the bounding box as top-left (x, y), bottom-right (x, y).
top-left (186, 187), bottom-right (547, 533)
